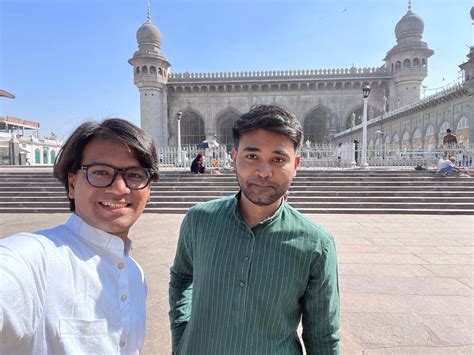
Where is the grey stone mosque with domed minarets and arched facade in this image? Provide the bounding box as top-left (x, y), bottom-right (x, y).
top-left (129, 1), bottom-right (474, 151)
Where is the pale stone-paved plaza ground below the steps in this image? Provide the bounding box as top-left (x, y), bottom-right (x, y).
top-left (0, 214), bottom-right (474, 355)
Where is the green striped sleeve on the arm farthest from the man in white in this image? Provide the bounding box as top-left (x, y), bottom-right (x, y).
top-left (302, 235), bottom-right (339, 355)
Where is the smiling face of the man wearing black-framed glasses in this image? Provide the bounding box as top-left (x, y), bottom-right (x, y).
top-left (68, 138), bottom-right (150, 239)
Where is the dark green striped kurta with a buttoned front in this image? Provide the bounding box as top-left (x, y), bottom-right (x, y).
top-left (169, 194), bottom-right (339, 355)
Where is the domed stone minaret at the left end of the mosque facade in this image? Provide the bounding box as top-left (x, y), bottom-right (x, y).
top-left (128, 0), bottom-right (171, 147)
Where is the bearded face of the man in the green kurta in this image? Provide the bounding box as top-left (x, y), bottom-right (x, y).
top-left (232, 129), bottom-right (300, 206)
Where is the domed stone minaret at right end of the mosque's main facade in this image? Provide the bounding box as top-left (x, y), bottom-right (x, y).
top-left (384, 0), bottom-right (434, 111)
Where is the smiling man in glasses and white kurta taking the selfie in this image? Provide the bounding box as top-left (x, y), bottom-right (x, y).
top-left (0, 119), bottom-right (159, 354)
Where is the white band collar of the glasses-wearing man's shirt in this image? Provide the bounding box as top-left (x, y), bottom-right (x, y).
top-left (65, 213), bottom-right (132, 256)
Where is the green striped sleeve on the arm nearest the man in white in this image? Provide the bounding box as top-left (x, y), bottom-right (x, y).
top-left (169, 213), bottom-right (193, 352)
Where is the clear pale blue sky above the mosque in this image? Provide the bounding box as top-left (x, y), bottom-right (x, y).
top-left (0, 0), bottom-right (473, 138)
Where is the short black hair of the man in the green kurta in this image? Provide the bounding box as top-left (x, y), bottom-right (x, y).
top-left (232, 105), bottom-right (303, 151)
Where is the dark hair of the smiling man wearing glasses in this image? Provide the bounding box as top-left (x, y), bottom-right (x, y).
top-left (53, 118), bottom-right (160, 212)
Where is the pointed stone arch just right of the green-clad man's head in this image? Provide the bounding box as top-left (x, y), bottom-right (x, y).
top-left (303, 105), bottom-right (331, 143)
